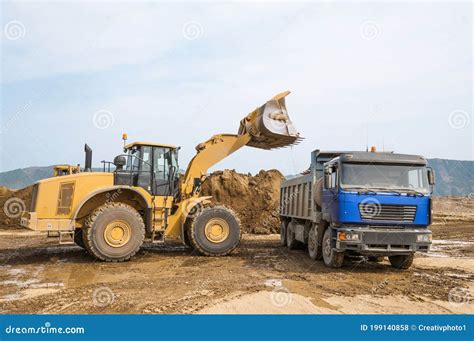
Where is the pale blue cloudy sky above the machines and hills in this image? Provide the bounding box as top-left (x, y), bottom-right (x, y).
top-left (0, 1), bottom-right (474, 174)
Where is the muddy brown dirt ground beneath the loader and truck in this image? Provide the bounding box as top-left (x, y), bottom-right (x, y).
top-left (0, 226), bottom-right (474, 314)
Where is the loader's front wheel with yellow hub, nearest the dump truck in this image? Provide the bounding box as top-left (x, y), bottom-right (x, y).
top-left (186, 206), bottom-right (242, 256)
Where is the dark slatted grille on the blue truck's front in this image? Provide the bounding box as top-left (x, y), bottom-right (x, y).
top-left (359, 201), bottom-right (416, 223)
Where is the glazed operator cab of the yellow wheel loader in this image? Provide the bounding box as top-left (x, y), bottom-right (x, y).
top-left (114, 142), bottom-right (179, 196)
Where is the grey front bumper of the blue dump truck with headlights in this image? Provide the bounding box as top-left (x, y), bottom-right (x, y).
top-left (336, 227), bottom-right (431, 256)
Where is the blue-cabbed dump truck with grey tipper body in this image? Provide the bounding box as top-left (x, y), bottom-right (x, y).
top-left (279, 149), bottom-right (435, 269)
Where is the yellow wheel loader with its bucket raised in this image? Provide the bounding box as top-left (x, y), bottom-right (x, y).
top-left (21, 91), bottom-right (301, 262)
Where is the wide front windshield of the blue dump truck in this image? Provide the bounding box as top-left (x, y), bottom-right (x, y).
top-left (341, 163), bottom-right (430, 194)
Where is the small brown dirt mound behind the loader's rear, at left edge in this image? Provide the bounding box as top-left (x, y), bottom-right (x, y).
top-left (0, 186), bottom-right (33, 229)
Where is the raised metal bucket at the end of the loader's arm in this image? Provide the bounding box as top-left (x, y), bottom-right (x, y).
top-left (239, 91), bottom-right (302, 149)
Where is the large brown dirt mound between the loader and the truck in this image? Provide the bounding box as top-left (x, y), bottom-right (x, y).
top-left (201, 169), bottom-right (284, 234)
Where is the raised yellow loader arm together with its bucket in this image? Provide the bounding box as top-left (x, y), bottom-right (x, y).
top-left (181, 91), bottom-right (301, 197)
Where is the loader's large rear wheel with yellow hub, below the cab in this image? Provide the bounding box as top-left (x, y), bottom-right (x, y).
top-left (82, 202), bottom-right (145, 262)
